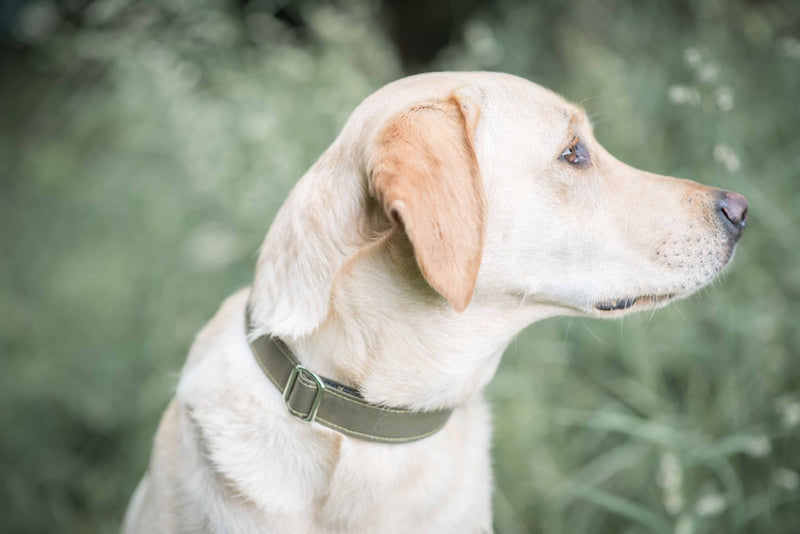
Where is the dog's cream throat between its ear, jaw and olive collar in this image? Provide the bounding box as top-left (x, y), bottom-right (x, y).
top-left (253, 229), bottom-right (550, 410)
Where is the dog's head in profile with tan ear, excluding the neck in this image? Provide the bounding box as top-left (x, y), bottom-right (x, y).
top-left (362, 73), bottom-right (747, 317)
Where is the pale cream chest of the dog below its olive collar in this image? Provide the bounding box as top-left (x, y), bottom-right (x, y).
top-left (177, 296), bottom-right (491, 532)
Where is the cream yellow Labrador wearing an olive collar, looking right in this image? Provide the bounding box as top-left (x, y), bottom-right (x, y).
top-left (123, 72), bottom-right (748, 533)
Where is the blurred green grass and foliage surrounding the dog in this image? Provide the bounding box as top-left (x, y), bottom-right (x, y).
top-left (0, 0), bottom-right (800, 534)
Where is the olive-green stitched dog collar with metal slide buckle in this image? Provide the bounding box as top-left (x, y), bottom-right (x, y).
top-left (245, 310), bottom-right (453, 443)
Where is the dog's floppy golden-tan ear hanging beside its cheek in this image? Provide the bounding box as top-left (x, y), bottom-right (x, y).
top-left (370, 94), bottom-right (486, 311)
